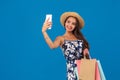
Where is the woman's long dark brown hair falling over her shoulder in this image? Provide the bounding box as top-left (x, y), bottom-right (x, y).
top-left (64, 16), bottom-right (90, 49)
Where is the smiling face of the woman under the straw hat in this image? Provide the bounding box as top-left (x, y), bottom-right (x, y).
top-left (65, 17), bottom-right (76, 31)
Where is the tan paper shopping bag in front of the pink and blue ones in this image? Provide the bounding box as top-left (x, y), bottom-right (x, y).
top-left (76, 59), bottom-right (96, 80)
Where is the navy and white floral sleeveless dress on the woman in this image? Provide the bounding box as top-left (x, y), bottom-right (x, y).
top-left (61, 40), bottom-right (83, 80)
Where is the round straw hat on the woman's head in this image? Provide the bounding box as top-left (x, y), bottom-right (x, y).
top-left (60, 12), bottom-right (84, 28)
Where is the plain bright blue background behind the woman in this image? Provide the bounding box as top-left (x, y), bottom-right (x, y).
top-left (0, 0), bottom-right (120, 80)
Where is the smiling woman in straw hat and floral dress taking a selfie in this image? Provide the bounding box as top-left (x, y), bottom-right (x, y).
top-left (42, 12), bottom-right (89, 80)
